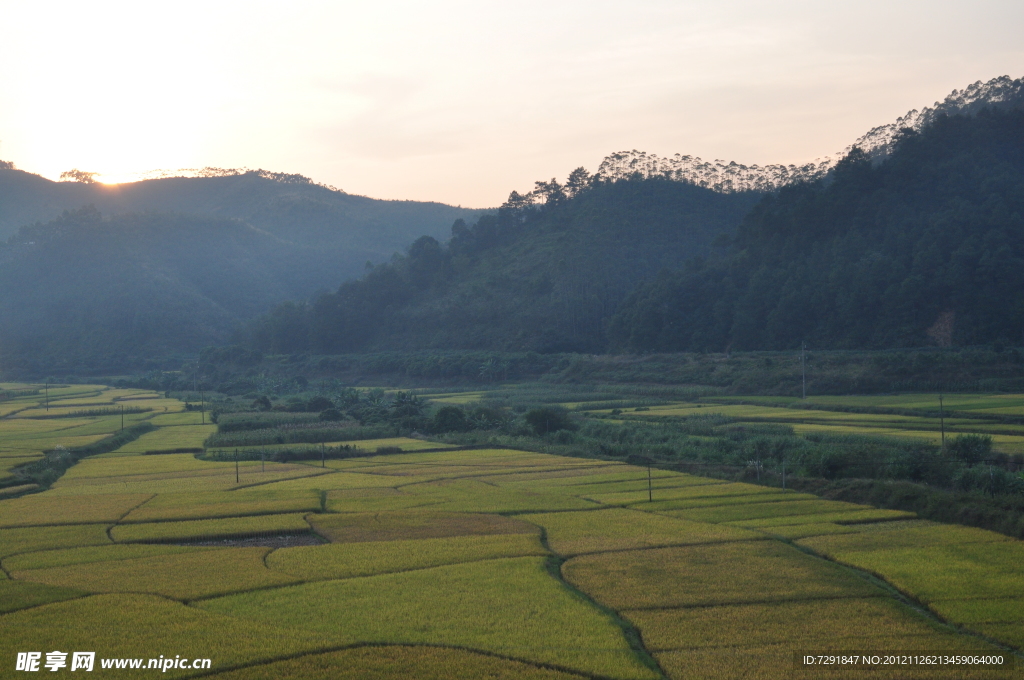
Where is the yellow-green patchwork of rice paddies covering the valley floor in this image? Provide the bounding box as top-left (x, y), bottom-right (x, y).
top-left (0, 385), bottom-right (1024, 680)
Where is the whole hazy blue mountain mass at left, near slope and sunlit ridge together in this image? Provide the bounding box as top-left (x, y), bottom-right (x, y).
top-left (0, 164), bottom-right (480, 372)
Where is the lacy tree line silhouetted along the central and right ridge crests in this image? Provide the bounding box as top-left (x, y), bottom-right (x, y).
top-left (597, 76), bottom-right (1024, 193)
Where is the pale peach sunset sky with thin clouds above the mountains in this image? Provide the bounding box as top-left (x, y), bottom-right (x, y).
top-left (0, 0), bottom-right (1024, 208)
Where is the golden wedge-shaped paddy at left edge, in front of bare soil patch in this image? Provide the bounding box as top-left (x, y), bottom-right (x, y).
top-left (11, 548), bottom-right (298, 600)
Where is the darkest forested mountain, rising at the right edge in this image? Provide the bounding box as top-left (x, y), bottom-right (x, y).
top-left (609, 110), bottom-right (1024, 351)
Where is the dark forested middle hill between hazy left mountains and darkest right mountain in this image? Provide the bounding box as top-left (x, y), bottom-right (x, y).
top-left (249, 178), bottom-right (760, 353)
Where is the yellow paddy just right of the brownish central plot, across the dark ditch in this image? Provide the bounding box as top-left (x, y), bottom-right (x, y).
top-left (524, 508), bottom-right (759, 556)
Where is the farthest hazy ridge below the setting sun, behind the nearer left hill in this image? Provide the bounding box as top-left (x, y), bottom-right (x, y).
top-left (0, 164), bottom-right (481, 276)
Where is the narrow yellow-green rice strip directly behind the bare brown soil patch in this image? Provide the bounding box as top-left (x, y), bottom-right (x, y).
top-left (111, 512), bottom-right (309, 543)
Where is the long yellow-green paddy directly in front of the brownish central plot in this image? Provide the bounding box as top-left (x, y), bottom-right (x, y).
top-left (266, 534), bottom-right (548, 581)
